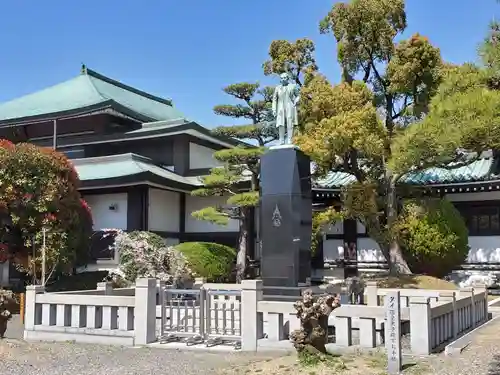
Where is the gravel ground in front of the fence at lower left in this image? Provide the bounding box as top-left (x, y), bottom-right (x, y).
top-left (0, 317), bottom-right (280, 375)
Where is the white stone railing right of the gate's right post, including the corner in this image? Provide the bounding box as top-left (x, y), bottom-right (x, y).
top-left (252, 288), bottom-right (488, 354)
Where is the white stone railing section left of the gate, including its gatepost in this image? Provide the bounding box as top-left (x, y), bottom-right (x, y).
top-left (24, 279), bottom-right (156, 345)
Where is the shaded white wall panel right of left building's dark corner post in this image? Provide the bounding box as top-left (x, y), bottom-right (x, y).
top-left (148, 188), bottom-right (180, 232)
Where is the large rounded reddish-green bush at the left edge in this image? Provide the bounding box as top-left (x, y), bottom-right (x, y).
top-left (0, 141), bottom-right (92, 276)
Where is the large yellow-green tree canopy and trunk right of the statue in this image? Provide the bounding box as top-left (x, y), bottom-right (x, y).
top-left (290, 0), bottom-right (500, 273)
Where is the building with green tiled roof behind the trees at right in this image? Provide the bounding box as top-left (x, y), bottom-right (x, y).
top-left (313, 152), bottom-right (500, 279)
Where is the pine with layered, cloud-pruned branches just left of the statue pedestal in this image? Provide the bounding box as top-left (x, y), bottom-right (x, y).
top-left (192, 83), bottom-right (277, 282)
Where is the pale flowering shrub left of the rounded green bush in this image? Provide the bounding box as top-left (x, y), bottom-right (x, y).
top-left (110, 230), bottom-right (192, 286)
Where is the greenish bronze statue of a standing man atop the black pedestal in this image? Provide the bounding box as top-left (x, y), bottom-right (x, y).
top-left (273, 73), bottom-right (300, 145)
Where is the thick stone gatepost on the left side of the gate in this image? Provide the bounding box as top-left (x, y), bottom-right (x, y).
top-left (134, 278), bottom-right (156, 345)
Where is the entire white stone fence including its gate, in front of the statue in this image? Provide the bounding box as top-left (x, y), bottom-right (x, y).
top-left (24, 279), bottom-right (488, 354)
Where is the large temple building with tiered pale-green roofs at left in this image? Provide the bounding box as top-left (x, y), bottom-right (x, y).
top-left (0, 66), bottom-right (248, 283)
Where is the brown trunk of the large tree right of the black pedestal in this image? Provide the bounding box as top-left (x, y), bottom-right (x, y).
top-left (384, 170), bottom-right (412, 275)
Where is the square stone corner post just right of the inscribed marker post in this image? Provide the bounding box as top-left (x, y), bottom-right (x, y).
top-left (410, 297), bottom-right (432, 355)
